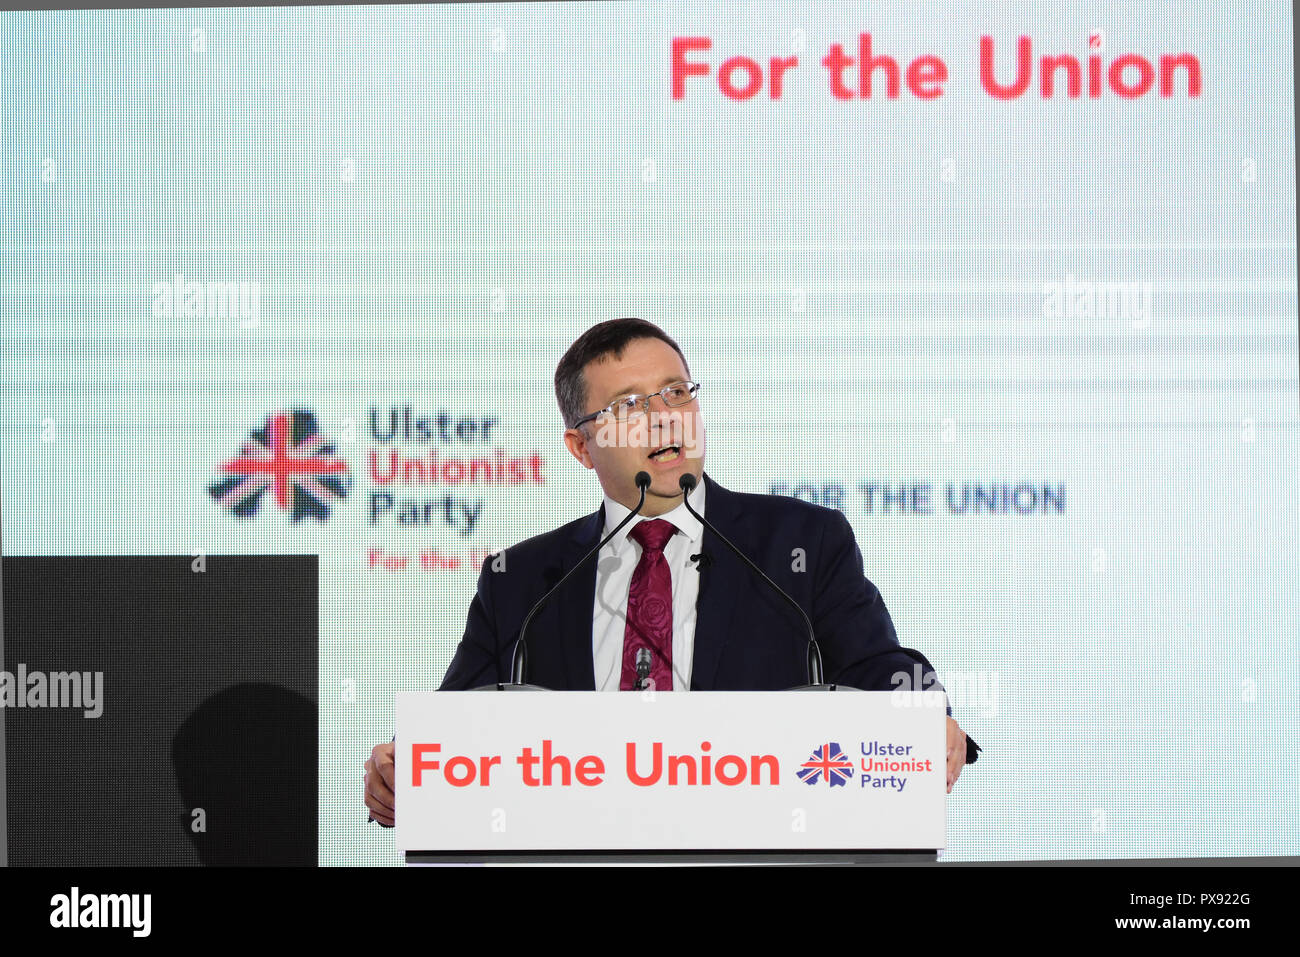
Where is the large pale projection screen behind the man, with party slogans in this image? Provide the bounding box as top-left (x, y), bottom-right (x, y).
top-left (0, 0), bottom-right (1300, 865)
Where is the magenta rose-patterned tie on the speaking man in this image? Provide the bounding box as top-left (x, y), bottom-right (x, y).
top-left (619, 519), bottom-right (677, 692)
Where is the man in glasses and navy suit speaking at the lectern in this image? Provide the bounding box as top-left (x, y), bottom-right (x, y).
top-left (365, 319), bottom-right (979, 827)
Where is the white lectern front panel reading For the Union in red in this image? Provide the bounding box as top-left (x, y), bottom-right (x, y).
top-left (395, 690), bottom-right (946, 863)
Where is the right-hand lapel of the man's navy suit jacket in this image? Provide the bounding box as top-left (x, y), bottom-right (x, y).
top-left (690, 473), bottom-right (753, 690)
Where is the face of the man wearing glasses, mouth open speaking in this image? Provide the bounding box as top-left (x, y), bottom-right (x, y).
top-left (564, 338), bottom-right (705, 515)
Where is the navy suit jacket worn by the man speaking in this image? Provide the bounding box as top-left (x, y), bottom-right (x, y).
top-left (442, 475), bottom-right (979, 761)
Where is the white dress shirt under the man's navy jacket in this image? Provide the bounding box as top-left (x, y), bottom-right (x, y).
top-left (592, 482), bottom-right (707, 692)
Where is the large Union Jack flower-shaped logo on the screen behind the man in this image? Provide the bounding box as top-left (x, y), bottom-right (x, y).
top-left (208, 408), bottom-right (352, 521)
